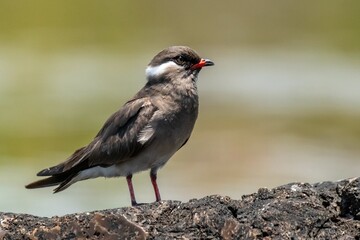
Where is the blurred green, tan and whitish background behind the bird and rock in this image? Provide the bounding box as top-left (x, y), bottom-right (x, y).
top-left (0, 0), bottom-right (360, 216)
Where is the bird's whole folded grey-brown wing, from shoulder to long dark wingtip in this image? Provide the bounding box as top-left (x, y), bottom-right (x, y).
top-left (38, 97), bottom-right (157, 176)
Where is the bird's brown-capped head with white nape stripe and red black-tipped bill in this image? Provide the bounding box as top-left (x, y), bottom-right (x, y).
top-left (146, 46), bottom-right (214, 82)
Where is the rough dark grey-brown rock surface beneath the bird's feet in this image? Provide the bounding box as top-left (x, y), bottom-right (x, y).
top-left (0, 178), bottom-right (360, 239)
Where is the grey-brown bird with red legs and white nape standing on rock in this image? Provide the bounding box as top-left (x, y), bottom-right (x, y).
top-left (25, 46), bottom-right (214, 206)
